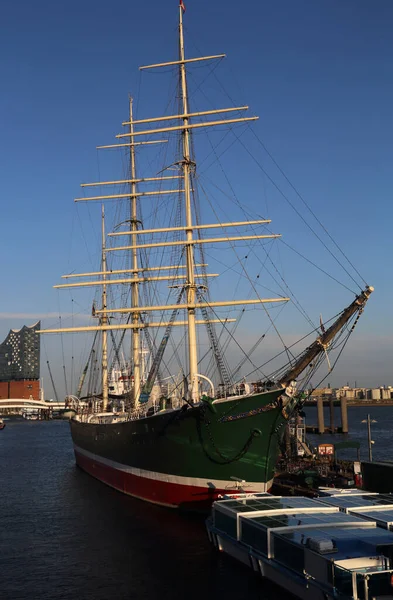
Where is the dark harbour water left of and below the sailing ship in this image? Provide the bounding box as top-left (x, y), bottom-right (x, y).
top-left (0, 420), bottom-right (289, 600)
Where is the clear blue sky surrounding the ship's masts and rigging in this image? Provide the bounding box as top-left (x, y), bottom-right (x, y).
top-left (0, 0), bottom-right (393, 396)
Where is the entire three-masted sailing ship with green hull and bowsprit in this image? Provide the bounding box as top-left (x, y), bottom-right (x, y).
top-left (38, 2), bottom-right (372, 507)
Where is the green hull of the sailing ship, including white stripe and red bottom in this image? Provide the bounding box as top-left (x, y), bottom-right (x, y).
top-left (70, 390), bottom-right (292, 506)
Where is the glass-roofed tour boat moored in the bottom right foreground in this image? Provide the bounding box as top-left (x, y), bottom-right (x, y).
top-left (207, 494), bottom-right (393, 600)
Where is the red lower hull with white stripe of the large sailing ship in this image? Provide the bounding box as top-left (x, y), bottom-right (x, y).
top-left (74, 446), bottom-right (271, 508)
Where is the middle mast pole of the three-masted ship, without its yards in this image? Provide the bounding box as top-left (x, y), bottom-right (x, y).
top-left (130, 97), bottom-right (141, 405)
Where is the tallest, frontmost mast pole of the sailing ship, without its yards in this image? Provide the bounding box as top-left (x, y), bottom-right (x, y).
top-left (179, 3), bottom-right (198, 402)
